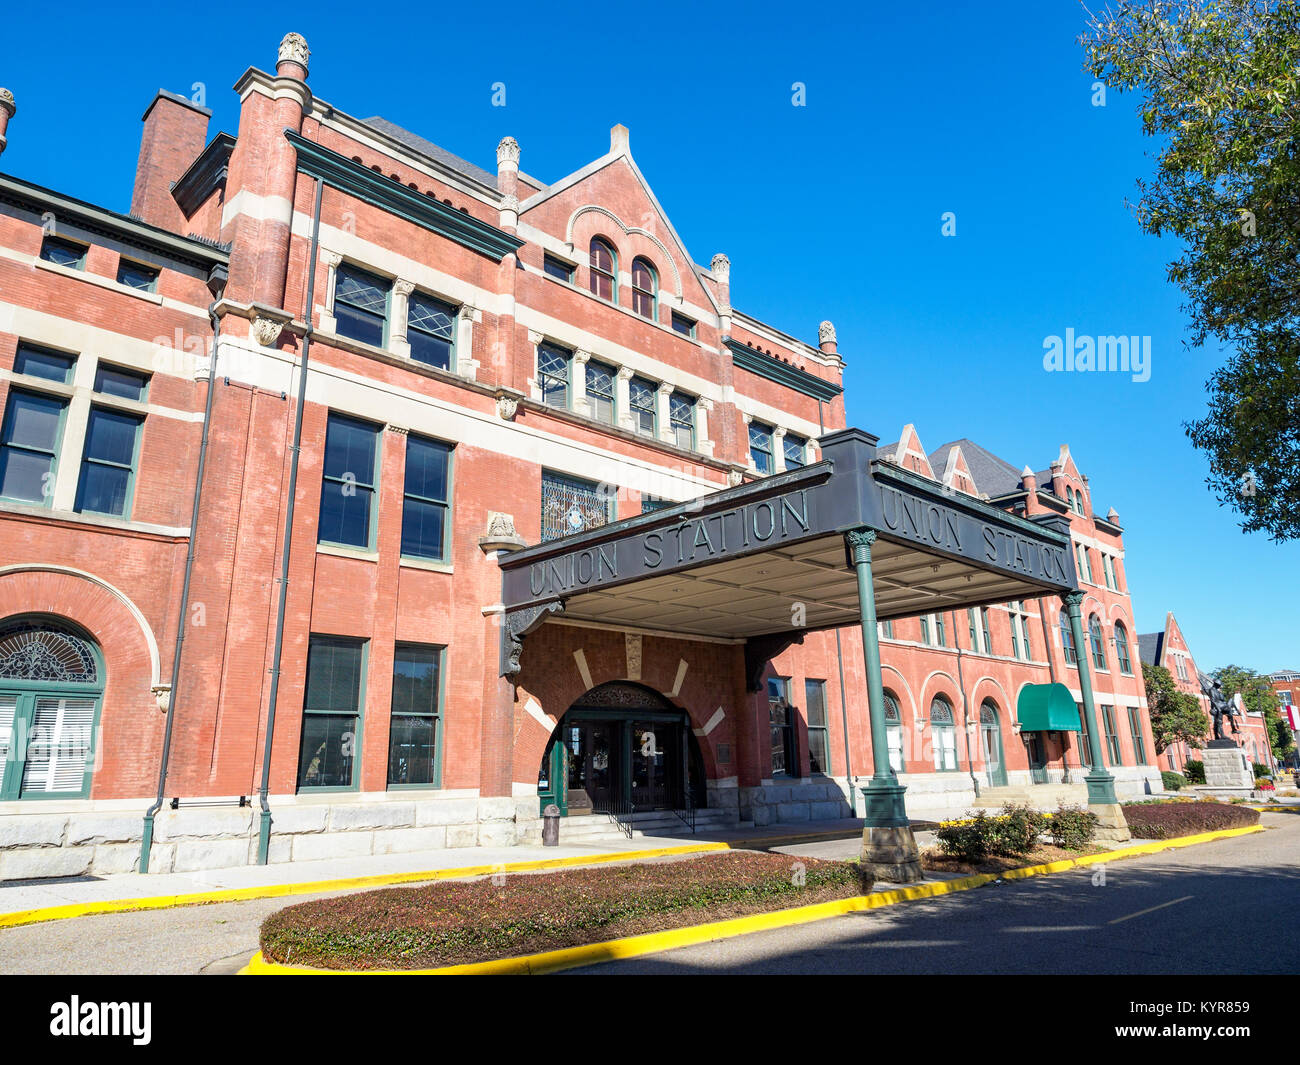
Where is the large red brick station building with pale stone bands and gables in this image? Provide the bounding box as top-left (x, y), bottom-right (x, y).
top-left (0, 34), bottom-right (1158, 878)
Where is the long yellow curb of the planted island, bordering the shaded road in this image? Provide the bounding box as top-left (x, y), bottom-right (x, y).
top-left (239, 824), bottom-right (1264, 977)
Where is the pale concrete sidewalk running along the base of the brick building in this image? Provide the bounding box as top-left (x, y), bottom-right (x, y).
top-left (0, 818), bottom-right (862, 926)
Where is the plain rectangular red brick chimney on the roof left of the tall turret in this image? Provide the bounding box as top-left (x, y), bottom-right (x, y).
top-left (131, 88), bottom-right (212, 234)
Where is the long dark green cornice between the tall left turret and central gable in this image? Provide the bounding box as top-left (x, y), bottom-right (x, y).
top-left (285, 129), bottom-right (525, 263)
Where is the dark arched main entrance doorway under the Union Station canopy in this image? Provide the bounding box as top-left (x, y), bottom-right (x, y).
top-left (537, 681), bottom-right (706, 817)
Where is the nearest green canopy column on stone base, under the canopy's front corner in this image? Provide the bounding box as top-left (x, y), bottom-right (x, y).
top-left (844, 529), bottom-right (924, 884)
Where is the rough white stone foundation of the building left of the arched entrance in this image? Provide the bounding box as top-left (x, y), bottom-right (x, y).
top-left (0, 795), bottom-right (542, 880)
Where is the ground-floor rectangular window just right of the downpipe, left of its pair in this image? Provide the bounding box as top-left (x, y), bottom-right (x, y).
top-left (298, 636), bottom-right (365, 788)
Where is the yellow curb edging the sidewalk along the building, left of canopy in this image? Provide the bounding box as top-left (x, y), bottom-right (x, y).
top-left (0, 841), bottom-right (731, 928)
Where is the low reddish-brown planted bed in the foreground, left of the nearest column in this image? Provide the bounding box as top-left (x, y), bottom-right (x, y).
top-left (261, 852), bottom-right (865, 969)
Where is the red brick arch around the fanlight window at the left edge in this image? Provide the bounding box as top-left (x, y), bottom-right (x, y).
top-left (0, 566), bottom-right (166, 798)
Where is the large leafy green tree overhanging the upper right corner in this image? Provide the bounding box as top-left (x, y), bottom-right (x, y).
top-left (1079, 0), bottom-right (1300, 540)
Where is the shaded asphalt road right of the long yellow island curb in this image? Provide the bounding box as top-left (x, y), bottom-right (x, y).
top-left (569, 814), bottom-right (1300, 975)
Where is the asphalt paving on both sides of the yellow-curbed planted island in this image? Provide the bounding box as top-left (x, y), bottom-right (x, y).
top-left (0, 815), bottom-right (1300, 974)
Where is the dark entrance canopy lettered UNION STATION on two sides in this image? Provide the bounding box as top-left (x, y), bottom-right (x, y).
top-left (501, 429), bottom-right (1076, 672)
